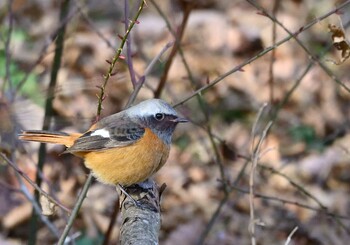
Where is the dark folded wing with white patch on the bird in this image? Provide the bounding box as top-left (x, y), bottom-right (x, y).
top-left (66, 114), bottom-right (145, 153)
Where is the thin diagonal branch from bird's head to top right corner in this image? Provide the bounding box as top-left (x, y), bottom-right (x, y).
top-left (174, 0), bottom-right (350, 106)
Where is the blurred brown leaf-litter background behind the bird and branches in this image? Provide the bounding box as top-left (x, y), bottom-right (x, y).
top-left (0, 0), bottom-right (350, 245)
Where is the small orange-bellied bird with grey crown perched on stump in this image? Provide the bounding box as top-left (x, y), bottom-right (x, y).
top-left (19, 99), bottom-right (188, 186)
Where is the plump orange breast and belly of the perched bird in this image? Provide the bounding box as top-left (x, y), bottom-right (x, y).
top-left (81, 129), bottom-right (170, 186)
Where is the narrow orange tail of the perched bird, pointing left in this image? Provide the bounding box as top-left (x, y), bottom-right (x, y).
top-left (18, 130), bottom-right (81, 147)
